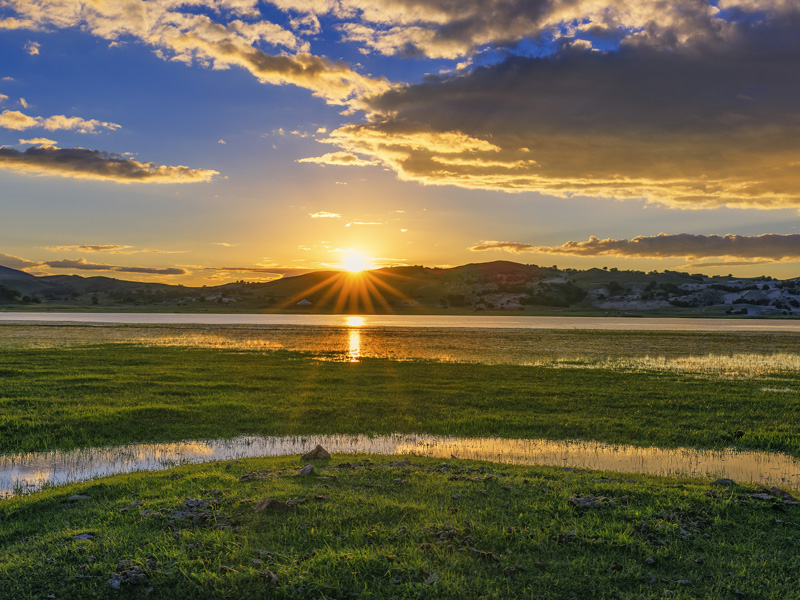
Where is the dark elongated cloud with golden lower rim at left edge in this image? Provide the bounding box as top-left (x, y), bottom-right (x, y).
top-left (0, 146), bottom-right (219, 183)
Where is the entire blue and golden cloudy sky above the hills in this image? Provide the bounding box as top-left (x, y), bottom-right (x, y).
top-left (0, 0), bottom-right (800, 285)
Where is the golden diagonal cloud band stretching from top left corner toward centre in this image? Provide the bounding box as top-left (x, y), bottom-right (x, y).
top-left (4, 0), bottom-right (389, 104)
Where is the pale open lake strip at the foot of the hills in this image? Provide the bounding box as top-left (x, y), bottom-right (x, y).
top-left (0, 312), bottom-right (800, 333)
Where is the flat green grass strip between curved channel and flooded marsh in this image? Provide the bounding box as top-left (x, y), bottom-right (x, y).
top-left (0, 344), bottom-right (800, 455)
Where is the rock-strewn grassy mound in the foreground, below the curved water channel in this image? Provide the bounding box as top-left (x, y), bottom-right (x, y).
top-left (0, 456), bottom-right (800, 600)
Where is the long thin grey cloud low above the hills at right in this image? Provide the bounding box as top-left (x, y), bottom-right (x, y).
top-left (470, 233), bottom-right (800, 261)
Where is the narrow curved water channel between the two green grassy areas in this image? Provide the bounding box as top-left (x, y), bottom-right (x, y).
top-left (0, 434), bottom-right (800, 498)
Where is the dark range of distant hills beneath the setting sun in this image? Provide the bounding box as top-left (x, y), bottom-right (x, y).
top-left (0, 261), bottom-right (800, 317)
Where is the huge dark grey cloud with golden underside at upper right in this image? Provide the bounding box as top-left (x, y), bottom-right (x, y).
top-left (308, 9), bottom-right (800, 209)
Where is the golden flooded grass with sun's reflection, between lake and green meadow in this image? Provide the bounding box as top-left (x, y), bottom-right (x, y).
top-left (0, 317), bottom-right (800, 377)
